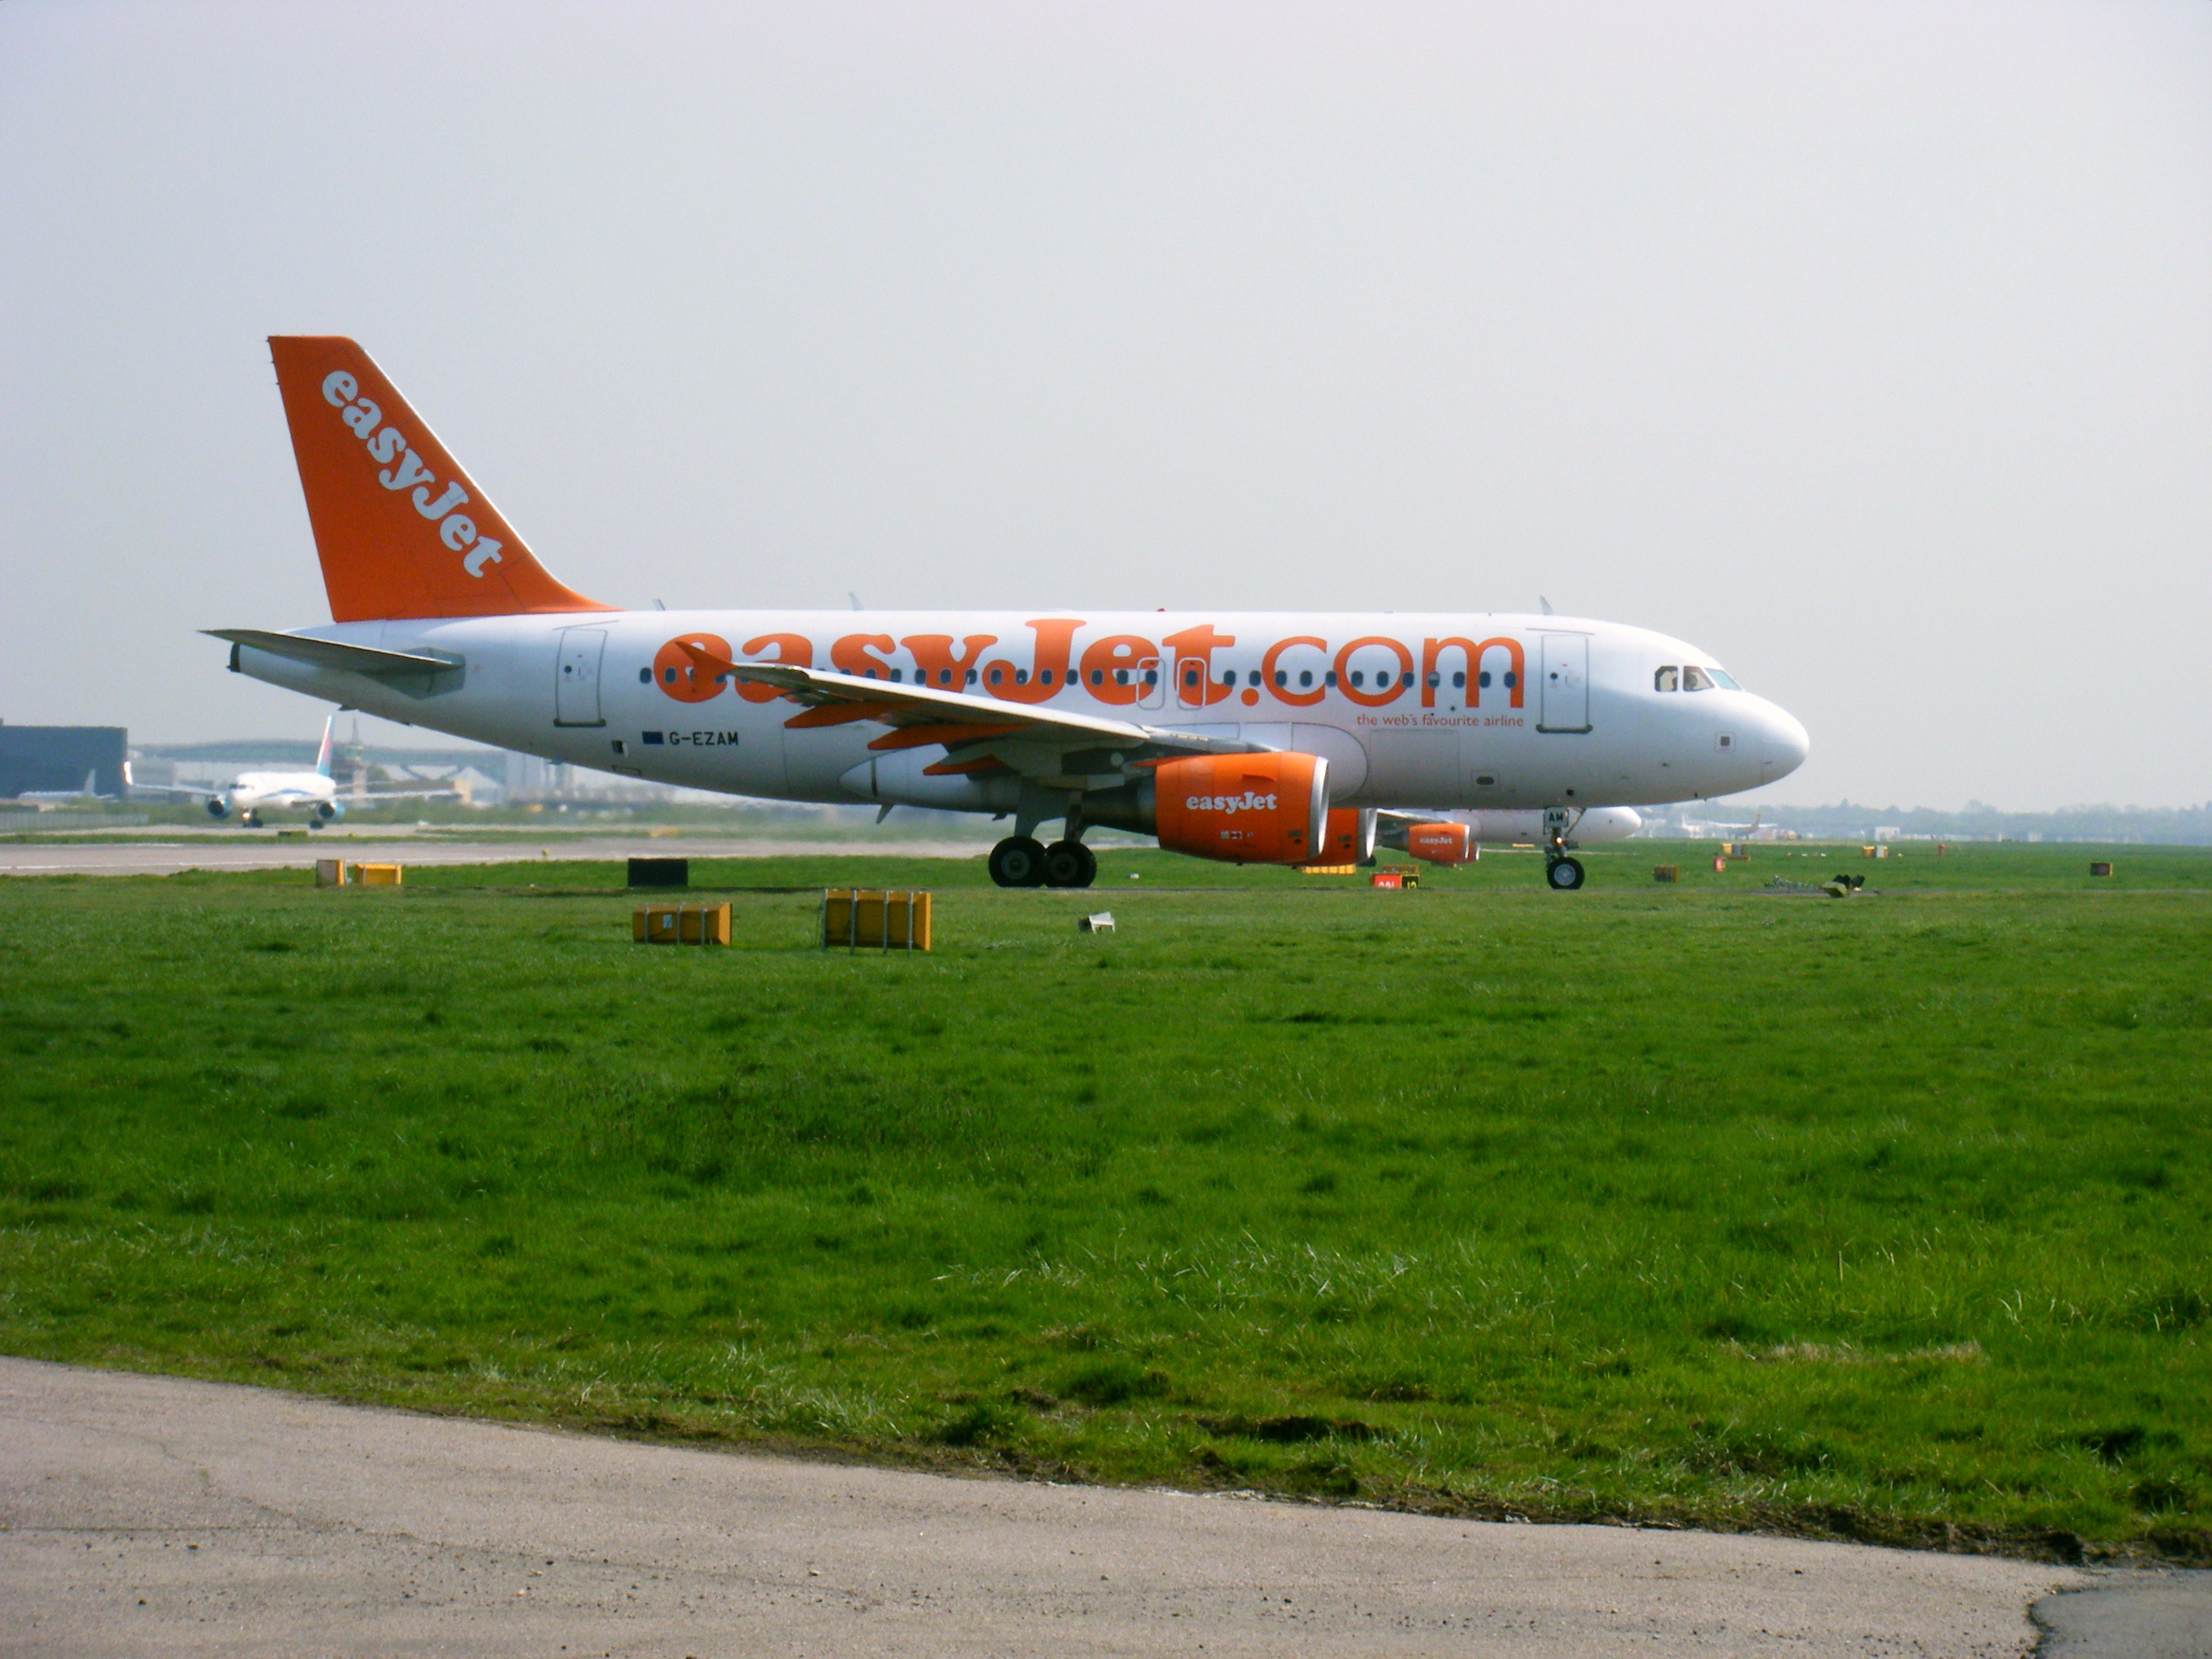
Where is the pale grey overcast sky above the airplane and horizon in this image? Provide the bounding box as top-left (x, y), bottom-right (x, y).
top-left (0, 0), bottom-right (2212, 810)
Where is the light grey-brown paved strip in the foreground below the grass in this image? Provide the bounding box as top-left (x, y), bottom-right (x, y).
top-left (0, 1360), bottom-right (2212, 1659)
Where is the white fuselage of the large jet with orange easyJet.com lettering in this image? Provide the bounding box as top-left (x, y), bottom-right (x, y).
top-left (234, 611), bottom-right (1807, 812)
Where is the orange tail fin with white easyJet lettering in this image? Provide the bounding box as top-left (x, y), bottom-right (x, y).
top-left (270, 334), bottom-right (613, 621)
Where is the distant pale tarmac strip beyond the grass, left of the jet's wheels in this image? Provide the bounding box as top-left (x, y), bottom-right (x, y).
top-left (0, 830), bottom-right (991, 876)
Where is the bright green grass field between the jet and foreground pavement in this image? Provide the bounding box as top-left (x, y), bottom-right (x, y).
top-left (0, 843), bottom-right (2212, 1561)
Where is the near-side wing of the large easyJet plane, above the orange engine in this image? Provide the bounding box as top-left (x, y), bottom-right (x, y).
top-left (677, 639), bottom-right (1270, 783)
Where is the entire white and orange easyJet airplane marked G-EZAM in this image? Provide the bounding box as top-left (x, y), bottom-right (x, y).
top-left (210, 336), bottom-right (1807, 889)
